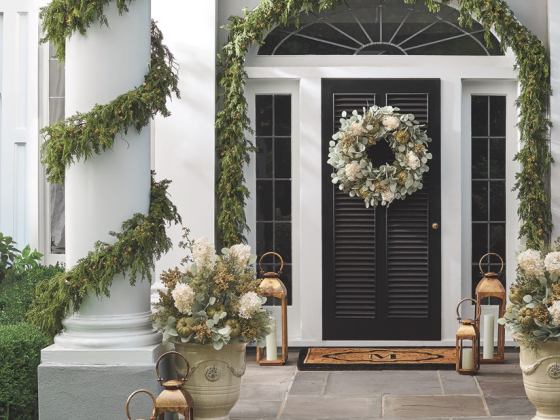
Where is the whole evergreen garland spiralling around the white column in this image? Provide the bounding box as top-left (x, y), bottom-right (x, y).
top-left (27, 0), bottom-right (181, 337)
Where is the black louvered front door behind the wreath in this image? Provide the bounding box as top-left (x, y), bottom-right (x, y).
top-left (322, 79), bottom-right (441, 340)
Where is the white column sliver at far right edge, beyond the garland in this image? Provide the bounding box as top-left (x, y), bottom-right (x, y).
top-left (548, 0), bottom-right (560, 239)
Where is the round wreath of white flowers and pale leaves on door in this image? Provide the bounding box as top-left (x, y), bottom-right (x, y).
top-left (328, 105), bottom-right (432, 207)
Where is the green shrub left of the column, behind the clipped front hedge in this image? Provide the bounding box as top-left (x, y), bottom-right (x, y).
top-left (0, 264), bottom-right (64, 325)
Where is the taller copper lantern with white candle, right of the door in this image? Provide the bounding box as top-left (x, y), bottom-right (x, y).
top-left (476, 252), bottom-right (506, 363)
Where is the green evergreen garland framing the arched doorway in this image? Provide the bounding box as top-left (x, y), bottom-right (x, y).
top-left (216, 0), bottom-right (552, 248)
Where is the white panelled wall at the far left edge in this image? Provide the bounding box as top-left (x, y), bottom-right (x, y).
top-left (0, 0), bottom-right (39, 249)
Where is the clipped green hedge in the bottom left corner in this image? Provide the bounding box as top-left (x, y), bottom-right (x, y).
top-left (0, 322), bottom-right (50, 420)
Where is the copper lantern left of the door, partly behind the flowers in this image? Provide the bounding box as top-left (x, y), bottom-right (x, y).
top-left (257, 252), bottom-right (288, 366)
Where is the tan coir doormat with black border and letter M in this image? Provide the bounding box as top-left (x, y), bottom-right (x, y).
top-left (298, 347), bottom-right (455, 370)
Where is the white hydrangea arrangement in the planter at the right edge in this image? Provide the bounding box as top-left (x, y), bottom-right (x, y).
top-left (498, 240), bottom-right (560, 349)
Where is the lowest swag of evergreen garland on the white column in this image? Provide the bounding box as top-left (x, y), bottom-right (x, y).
top-left (27, 176), bottom-right (181, 337)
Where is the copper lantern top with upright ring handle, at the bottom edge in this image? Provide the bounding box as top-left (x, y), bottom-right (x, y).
top-left (154, 351), bottom-right (194, 420)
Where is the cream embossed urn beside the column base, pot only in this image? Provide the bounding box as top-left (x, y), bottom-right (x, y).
top-left (175, 343), bottom-right (247, 420)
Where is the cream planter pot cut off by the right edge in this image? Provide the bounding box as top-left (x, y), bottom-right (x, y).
top-left (519, 341), bottom-right (560, 420)
